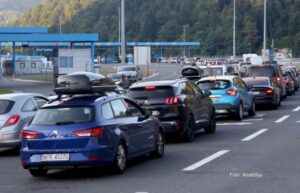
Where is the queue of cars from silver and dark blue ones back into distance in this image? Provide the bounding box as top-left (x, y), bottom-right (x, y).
top-left (0, 64), bottom-right (299, 177)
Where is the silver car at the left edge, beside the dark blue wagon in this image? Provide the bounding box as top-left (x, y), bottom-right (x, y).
top-left (0, 93), bottom-right (48, 147)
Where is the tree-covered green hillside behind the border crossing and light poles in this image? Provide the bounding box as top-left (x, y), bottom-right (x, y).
top-left (15, 0), bottom-right (300, 56)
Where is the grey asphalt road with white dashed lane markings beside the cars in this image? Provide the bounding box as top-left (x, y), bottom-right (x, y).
top-left (0, 66), bottom-right (300, 193)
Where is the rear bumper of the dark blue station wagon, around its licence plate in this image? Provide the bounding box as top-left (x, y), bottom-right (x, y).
top-left (21, 147), bottom-right (115, 169)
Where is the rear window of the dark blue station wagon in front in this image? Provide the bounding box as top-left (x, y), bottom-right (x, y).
top-left (32, 107), bottom-right (93, 125)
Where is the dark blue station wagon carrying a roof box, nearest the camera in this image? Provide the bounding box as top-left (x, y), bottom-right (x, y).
top-left (21, 72), bottom-right (164, 177)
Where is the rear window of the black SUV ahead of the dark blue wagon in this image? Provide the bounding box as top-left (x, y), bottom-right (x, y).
top-left (127, 87), bottom-right (174, 100)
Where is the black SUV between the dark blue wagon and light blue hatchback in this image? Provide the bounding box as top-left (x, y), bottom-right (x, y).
top-left (127, 79), bottom-right (216, 141)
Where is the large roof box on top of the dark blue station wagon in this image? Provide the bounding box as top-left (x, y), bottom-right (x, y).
top-left (54, 72), bottom-right (116, 95)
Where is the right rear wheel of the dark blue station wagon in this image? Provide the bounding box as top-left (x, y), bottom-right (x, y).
top-left (113, 142), bottom-right (127, 174)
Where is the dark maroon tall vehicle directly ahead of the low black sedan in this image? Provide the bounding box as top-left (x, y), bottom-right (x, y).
top-left (245, 62), bottom-right (287, 99)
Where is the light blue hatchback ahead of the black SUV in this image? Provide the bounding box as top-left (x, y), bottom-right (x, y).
top-left (197, 76), bottom-right (255, 121)
